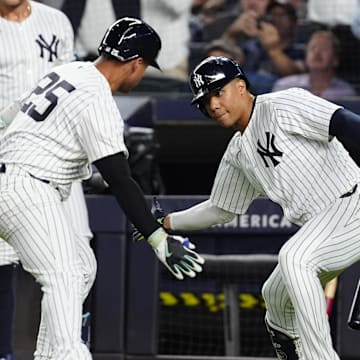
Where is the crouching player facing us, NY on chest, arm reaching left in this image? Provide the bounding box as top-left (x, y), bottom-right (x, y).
top-left (159, 57), bottom-right (360, 360)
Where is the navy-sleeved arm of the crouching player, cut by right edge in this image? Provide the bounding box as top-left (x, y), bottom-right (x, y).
top-left (329, 109), bottom-right (360, 166)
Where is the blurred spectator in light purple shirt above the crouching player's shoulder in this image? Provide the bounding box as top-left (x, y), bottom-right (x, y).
top-left (273, 30), bottom-right (356, 99)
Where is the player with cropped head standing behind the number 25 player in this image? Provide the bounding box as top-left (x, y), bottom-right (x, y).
top-left (0, 0), bottom-right (96, 360)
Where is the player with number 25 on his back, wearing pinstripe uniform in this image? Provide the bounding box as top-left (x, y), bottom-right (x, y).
top-left (0, 18), bottom-right (204, 360)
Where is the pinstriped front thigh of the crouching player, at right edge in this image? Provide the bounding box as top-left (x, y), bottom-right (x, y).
top-left (279, 193), bottom-right (360, 274)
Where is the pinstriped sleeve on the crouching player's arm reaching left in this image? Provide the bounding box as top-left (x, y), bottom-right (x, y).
top-left (210, 146), bottom-right (260, 214)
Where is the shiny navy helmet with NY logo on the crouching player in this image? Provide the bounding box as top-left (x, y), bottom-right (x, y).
top-left (190, 56), bottom-right (249, 116)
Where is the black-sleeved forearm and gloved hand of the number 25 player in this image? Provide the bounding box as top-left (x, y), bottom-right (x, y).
top-left (94, 153), bottom-right (204, 280)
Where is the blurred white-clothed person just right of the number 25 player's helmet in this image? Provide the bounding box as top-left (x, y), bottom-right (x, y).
top-left (141, 0), bottom-right (192, 81)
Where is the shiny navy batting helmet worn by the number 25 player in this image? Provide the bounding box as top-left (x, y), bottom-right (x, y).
top-left (98, 17), bottom-right (161, 69)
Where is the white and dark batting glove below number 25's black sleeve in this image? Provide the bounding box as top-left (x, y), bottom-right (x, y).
top-left (148, 228), bottom-right (205, 280)
